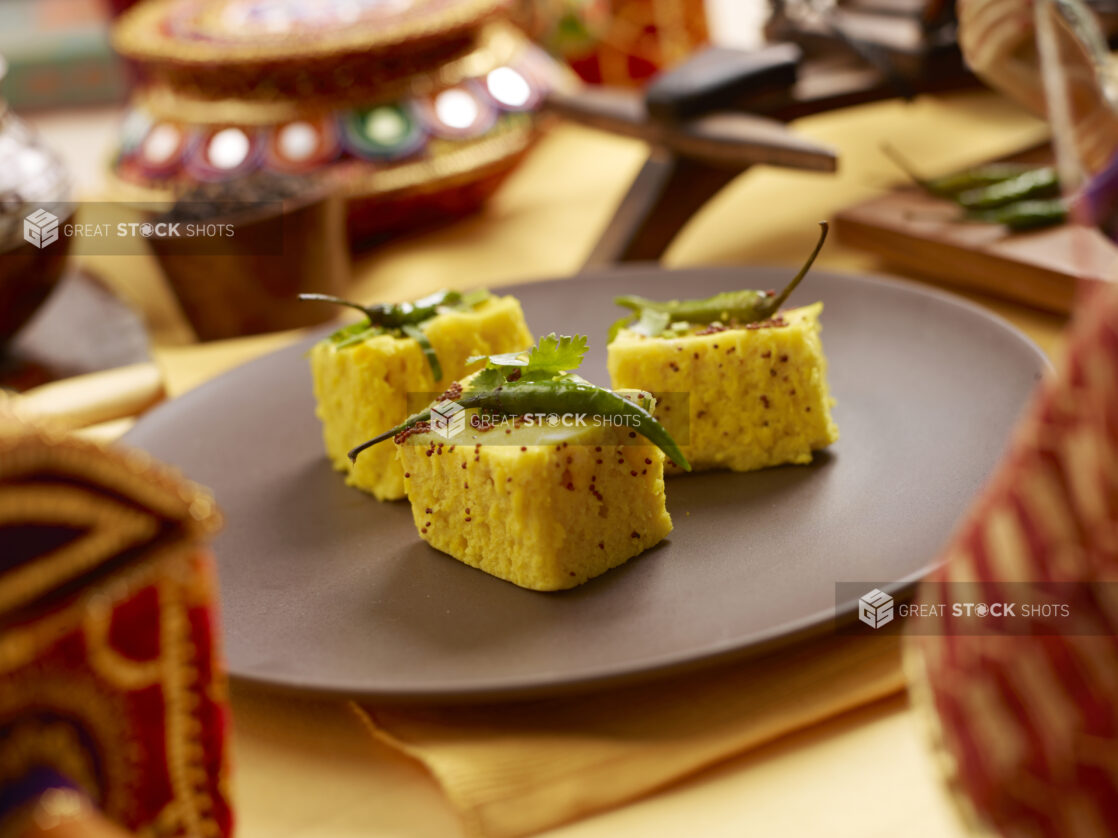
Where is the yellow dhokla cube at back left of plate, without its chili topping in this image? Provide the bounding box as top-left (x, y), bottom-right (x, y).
top-left (310, 296), bottom-right (532, 501)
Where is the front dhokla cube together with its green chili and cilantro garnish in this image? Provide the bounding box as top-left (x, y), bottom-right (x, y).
top-left (353, 335), bottom-right (688, 590)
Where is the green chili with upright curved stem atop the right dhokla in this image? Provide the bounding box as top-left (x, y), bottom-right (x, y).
top-left (612, 221), bottom-right (827, 336)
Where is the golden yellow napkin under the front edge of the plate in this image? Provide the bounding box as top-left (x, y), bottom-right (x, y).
top-left (353, 637), bottom-right (904, 838)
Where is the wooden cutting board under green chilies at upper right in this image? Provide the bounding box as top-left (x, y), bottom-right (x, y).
top-left (835, 152), bottom-right (1118, 313)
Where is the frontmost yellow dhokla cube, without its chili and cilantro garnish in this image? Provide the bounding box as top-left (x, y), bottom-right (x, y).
top-left (396, 428), bottom-right (672, 591)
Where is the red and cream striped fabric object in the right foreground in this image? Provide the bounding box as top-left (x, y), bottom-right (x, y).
top-left (908, 280), bottom-right (1118, 838)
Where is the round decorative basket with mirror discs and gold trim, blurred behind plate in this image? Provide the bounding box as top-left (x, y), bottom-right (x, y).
top-left (112, 0), bottom-right (561, 239)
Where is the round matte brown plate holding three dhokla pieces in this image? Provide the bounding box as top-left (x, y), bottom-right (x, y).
top-left (126, 267), bottom-right (1046, 702)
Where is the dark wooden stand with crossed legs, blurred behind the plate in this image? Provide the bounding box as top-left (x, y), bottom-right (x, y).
top-left (548, 22), bottom-right (974, 267)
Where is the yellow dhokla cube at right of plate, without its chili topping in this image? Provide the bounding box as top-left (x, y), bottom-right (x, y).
top-left (608, 303), bottom-right (839, 472)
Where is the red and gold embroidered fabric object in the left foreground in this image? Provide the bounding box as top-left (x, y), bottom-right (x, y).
top-left (0, 418), bottom-right (231, 838)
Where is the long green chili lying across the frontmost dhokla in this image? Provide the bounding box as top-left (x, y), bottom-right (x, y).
top-left (349, 378), bottom-right (691, 472)
